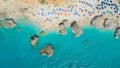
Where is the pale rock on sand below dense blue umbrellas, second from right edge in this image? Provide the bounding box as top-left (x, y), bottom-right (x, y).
top-left (103, 18), bottom-right (117, 29)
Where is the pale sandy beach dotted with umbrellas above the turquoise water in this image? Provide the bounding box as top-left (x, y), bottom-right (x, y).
top-left (0, 0), bottom-right (120, 30)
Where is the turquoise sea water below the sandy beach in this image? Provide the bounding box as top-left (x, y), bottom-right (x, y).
top-left (0, 18), bottom-right (120, 68)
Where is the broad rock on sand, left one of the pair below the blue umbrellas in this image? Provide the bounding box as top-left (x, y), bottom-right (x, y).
top-left (90, 15), bottom-right (102, 28)
